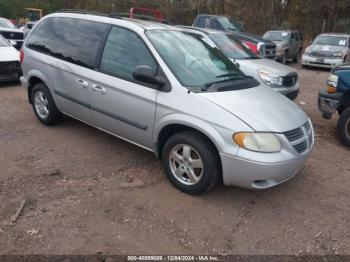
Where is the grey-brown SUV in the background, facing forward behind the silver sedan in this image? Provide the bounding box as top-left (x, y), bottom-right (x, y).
top-left (263, 30), bottom-right (303, 64)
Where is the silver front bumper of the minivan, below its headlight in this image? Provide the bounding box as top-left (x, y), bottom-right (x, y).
top-left (220, 148), bottom-right (312, 189)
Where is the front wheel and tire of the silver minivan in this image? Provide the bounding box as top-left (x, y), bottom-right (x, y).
top-left (162, 131), bottom-right (221, 195)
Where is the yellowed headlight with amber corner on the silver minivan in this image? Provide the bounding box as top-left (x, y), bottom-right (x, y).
top-left (233, 132), bottom-right (282, 153)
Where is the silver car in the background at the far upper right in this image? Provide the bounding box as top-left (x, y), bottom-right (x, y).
top-left (302, 33), bottom-right (350, 68)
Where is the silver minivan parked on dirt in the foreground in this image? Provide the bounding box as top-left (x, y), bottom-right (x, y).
top-left (21, 12), bottom-right (314, 194)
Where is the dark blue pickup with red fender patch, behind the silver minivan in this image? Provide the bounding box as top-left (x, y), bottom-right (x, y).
top-left (193, 14), bottom-right (276, 59)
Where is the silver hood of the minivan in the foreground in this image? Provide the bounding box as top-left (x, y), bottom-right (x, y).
top-left (200, 86), bottom-right (308, 133)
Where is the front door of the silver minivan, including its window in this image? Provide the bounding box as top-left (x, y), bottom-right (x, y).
top-left (91, 27), bottom-right (158, 149)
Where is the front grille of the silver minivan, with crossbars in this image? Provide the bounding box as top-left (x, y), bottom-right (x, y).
top-left (284, 121), bottom-right (314, 154)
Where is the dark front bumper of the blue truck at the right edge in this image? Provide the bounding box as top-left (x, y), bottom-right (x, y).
top-left (318, 90), bottom-right (343, 119)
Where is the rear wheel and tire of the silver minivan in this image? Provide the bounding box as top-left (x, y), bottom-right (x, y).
top-left (31, 83), bottom-right (62, 126)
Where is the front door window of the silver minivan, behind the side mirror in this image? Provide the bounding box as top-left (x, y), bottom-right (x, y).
top-left (100, 27), bottom-right (158, 80)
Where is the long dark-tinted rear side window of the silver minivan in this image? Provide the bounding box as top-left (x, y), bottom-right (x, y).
top-left (27, 17), bottom-right (108, 68)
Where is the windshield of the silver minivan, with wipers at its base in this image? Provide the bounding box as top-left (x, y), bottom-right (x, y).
top-left (146, 30), bottom-right (258, 92)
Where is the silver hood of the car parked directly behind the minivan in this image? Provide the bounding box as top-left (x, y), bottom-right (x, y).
top-left (236, 58), bottom-right (296, 76)
